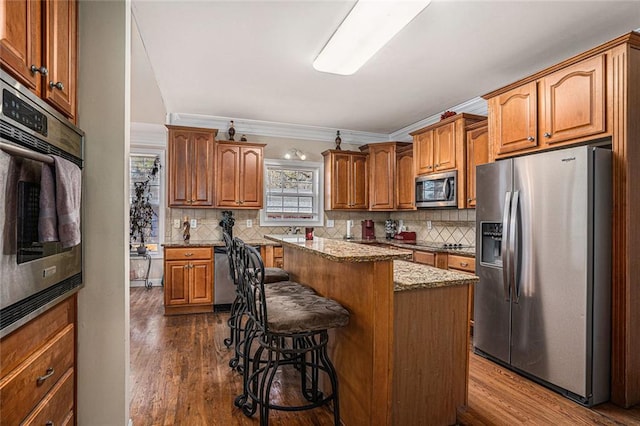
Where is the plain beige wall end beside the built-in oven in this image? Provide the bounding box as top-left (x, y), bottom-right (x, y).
top-left (77, 0), bottom-right (131, 426)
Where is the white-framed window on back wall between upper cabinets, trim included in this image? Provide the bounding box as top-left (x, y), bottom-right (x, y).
top-left (260, 159), bottom-right (323, 226)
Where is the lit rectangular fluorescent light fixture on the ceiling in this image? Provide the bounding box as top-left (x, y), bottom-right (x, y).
top-left (313, 0), bottom-right (431, 75)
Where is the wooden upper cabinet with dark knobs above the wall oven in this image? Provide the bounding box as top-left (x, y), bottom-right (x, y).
top-left (0, 0), bottom-right (77, 121)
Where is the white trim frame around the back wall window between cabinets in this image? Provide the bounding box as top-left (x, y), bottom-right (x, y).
top-left (260, 158), bottom-right (324, 226)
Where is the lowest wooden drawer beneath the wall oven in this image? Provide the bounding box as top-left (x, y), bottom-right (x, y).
top-left (22, 368), bottom-right (74, 426)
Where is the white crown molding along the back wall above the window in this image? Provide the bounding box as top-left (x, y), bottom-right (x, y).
top-left (167, 112), bottom-right (390, 145)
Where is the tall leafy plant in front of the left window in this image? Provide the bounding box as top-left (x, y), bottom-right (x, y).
top-left (129, 157), bottom-right (160, 254)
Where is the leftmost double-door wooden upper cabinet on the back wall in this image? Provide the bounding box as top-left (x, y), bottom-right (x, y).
top-left (167, 125), bottom-right (218, 207)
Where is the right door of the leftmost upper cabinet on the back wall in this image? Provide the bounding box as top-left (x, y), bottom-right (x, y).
top-left (190, 132), bottom-right (214, 207)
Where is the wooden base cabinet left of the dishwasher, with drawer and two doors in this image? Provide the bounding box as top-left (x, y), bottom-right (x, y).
top-left (164, 247), bottom-right (214, 315)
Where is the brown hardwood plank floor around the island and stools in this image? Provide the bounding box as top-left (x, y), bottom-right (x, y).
top-left (131, 287), bottom-right (640, 426)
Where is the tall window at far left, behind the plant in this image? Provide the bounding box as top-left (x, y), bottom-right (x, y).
top-left (129, 150), bottom-right (164, 253)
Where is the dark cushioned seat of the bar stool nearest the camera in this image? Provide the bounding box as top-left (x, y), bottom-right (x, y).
top-left (266, 294), bottom-right (349, 334)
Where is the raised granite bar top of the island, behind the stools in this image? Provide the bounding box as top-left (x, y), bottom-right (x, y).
top-left (265, 235), bottom-right (411, 263)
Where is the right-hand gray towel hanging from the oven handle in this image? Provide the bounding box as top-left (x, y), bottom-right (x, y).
top-left (52, 156), bottom-right (82, 248)
